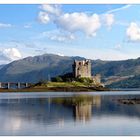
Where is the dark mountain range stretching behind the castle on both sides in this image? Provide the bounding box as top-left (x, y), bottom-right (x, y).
top-left (0, 54), bottom-right (140, 88)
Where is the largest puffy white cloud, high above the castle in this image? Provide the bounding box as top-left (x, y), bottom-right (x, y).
top-left (56, 13), bottom-right (101, 36)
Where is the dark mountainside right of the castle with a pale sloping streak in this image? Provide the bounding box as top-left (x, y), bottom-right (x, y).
top-left (94, 58), bottom-right (140, 88)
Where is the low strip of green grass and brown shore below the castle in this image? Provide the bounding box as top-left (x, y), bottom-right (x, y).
top-left (0, 81), bottom-right (108, 92)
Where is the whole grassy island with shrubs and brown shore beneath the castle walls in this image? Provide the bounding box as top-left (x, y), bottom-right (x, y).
top-left (0, 78), bottom-right (109, 92)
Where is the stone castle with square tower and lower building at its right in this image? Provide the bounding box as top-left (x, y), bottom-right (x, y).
top-left (73, 60), bottom-right (101, 84)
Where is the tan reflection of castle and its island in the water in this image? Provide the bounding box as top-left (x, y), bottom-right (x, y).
top-left (52, 95), bottom-right (101, 122)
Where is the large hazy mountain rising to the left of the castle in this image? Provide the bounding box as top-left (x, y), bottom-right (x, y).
top-left (0, 54), bottom-right (85, 82)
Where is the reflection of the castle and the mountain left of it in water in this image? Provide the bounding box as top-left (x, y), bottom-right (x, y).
top-left (0, 95), bottom-right (101, 122)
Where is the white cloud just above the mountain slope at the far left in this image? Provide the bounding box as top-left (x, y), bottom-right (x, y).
top-left (2, 48), bottom-right (22, 61)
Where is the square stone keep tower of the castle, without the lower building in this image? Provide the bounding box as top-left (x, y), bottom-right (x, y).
top-left (73, 60), bottom-right (91, 78)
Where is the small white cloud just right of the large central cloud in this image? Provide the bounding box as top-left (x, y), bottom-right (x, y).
top-left (104, 14), bottom-right (115, 28)
